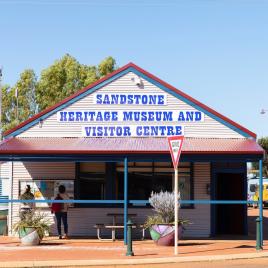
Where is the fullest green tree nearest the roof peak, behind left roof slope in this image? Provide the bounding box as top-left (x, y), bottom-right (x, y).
top-left (36, 54), bottom-right (115, 111)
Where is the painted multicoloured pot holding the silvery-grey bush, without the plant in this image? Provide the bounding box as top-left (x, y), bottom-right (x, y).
top-left (150, 224), bottom-right (183, 246)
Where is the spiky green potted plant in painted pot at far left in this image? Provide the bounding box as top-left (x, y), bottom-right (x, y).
top-left (13, 209), bottom-right (49, 246)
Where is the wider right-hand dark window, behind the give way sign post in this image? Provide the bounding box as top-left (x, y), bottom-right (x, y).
top-left (116, 162), bottom-right (193, 207)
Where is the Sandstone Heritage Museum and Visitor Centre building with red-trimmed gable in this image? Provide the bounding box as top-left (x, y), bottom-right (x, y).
top-left (0, 63), bottom-right (263, 237)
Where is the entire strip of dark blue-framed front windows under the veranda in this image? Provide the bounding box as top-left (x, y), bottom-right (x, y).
top-left (75, 162), bottom-right (193, 207)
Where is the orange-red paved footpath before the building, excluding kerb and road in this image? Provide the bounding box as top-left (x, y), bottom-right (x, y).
top-left (0, 208), bottom-right (268, 263)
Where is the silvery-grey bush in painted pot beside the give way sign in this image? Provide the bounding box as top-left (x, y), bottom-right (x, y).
top-left (144, 191), bottom-right (188, 246)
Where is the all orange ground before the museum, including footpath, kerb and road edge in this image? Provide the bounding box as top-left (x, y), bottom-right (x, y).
top-left (0, 208), bottom-right (268, 268)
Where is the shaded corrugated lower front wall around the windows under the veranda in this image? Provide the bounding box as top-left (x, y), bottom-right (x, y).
top-left (9, 162), bottom-right (210, 237)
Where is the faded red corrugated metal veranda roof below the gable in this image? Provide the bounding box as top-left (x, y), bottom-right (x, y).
top-left (0, 137), bottom-right (263, 155)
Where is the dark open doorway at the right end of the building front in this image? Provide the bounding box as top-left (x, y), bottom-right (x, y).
top-left (216, 173), bottom-right (246, 235)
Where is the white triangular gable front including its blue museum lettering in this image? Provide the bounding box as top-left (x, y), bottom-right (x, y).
top-left (18, 72), bottom-right (244, 138)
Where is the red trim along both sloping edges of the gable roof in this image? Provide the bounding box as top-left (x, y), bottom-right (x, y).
top-left (3, 62), bottom-right (257, 139)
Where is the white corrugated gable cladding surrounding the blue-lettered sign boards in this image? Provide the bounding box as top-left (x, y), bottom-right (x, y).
top-left (16, 72), bottom-right (242, 138)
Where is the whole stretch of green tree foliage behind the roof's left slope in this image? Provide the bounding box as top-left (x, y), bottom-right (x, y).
top-left (2, 54), bottom-right (116, 131)
